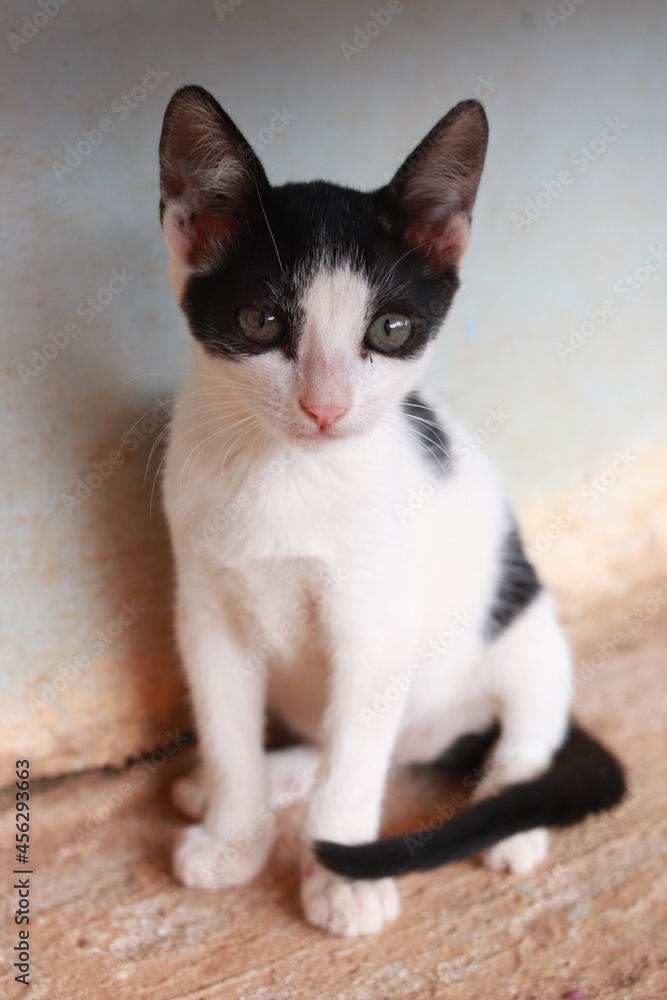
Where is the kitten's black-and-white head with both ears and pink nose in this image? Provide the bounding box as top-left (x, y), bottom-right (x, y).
top-left (160, 86), bottom-right (488, 443)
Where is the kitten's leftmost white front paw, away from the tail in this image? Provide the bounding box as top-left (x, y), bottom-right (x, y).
top-left (173, 825), bottom-right (272, 889)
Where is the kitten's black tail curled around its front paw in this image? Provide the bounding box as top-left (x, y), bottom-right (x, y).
top-left (315, 725), bottom-right (625, 878)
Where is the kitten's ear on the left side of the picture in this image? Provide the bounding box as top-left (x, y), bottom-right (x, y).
top-left (160, 86), bottom-right (269, 277)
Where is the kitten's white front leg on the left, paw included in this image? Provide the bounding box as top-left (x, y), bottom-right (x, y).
top-left (173, 590), bottom-right (275, 889)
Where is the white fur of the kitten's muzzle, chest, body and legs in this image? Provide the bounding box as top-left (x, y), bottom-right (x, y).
top-left (164, 270), bottom-right (570, 935)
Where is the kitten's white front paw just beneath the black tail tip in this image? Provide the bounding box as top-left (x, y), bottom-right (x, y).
top-left (301, 863), bottom-right (401, 937)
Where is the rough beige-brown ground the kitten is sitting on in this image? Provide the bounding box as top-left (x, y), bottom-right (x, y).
top-left (0, 582), bottom-right (667, 1000)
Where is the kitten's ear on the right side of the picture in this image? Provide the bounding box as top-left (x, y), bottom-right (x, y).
top-left (389, 101), bottom-right (489, 273)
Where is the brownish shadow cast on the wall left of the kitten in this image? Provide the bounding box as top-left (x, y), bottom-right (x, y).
top-left (7, 341), bottom-right (190, 783)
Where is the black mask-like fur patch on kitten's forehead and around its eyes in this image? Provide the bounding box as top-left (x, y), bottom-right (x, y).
top-left (181, 181), bottom-right (459, 359)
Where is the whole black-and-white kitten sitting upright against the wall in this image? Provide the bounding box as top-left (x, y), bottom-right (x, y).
top-left (160, 86), bottom-right (624, 936)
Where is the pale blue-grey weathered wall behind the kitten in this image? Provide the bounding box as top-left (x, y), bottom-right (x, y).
top-left (0, 0), bottom-right (667, 776)
